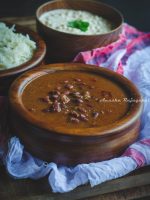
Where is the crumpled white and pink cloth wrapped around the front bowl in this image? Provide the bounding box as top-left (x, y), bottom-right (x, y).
top-left (0, 24), bottom-right (150, 193)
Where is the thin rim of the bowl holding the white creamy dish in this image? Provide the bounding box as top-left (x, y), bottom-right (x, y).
top-left (36, 0), bottom-right (124, 37)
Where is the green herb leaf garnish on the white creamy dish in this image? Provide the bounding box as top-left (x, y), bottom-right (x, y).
top-left (68, 20), bottom-right (90, 32)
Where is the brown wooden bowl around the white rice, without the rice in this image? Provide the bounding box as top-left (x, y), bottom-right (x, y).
top-left (0, 22), bottom-right (46, 95)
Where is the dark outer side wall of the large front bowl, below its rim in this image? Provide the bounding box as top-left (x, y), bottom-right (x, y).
top-left (11, 110), bottom-right (140, 165)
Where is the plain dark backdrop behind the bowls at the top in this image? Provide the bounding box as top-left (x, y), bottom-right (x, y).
top-left (0, 0), bottom-right (150, 31)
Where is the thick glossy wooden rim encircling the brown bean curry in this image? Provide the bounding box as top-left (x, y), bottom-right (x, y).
top-left (9, 63), bottom-right (143, 138)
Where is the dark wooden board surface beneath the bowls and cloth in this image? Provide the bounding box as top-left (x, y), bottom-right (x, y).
top-left (0, 17), bottom-right (150, 200)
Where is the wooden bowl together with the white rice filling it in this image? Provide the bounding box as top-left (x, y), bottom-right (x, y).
top-left (0, 22), bottom-right (46, 95)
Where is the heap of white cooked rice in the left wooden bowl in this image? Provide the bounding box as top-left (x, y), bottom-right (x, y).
top-left (0, 22), bottom-right (36, 70)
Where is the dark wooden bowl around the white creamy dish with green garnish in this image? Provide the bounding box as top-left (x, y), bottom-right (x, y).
top-left (36, 0), bottom-right (123, 63)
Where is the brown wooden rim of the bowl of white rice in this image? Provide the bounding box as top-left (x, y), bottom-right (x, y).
top-left (0, 21), bottom-right (46, 78)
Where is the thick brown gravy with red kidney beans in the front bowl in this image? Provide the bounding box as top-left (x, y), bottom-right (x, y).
top-left (22, 71), bottom-right (129, 128)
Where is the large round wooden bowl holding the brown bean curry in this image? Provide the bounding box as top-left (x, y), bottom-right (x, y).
top-left (9, 63), bottom-right (143, 165)
